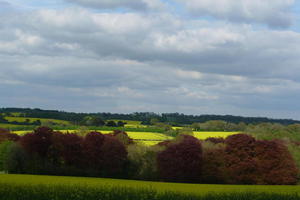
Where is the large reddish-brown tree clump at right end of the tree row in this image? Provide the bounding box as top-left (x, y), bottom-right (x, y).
top-left (225, 134), bottom-right (298, 185)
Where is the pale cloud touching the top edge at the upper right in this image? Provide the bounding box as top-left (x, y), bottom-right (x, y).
top-left (176, 0), bottom-right (295, 28)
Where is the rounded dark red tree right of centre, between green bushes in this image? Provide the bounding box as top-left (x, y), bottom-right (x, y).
top-left (157, 135), bottom-right (202, 182)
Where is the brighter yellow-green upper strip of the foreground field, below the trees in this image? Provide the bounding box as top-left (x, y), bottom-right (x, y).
top-left (0, 174), bottom-right (300, 195)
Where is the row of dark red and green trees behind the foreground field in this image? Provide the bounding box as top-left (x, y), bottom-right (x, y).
top-left (0, 127), bottom-right (299, 185)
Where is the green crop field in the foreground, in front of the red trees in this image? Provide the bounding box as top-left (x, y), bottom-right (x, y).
top-left (0, 174), bottom-right (300, 200)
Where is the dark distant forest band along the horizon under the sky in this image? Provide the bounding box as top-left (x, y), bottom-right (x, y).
top-left (0, 108), bottom-right (300, 125)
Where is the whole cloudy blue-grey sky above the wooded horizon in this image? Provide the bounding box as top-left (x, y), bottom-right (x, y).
top-left (0, 0), bottom-right (300, 119)
